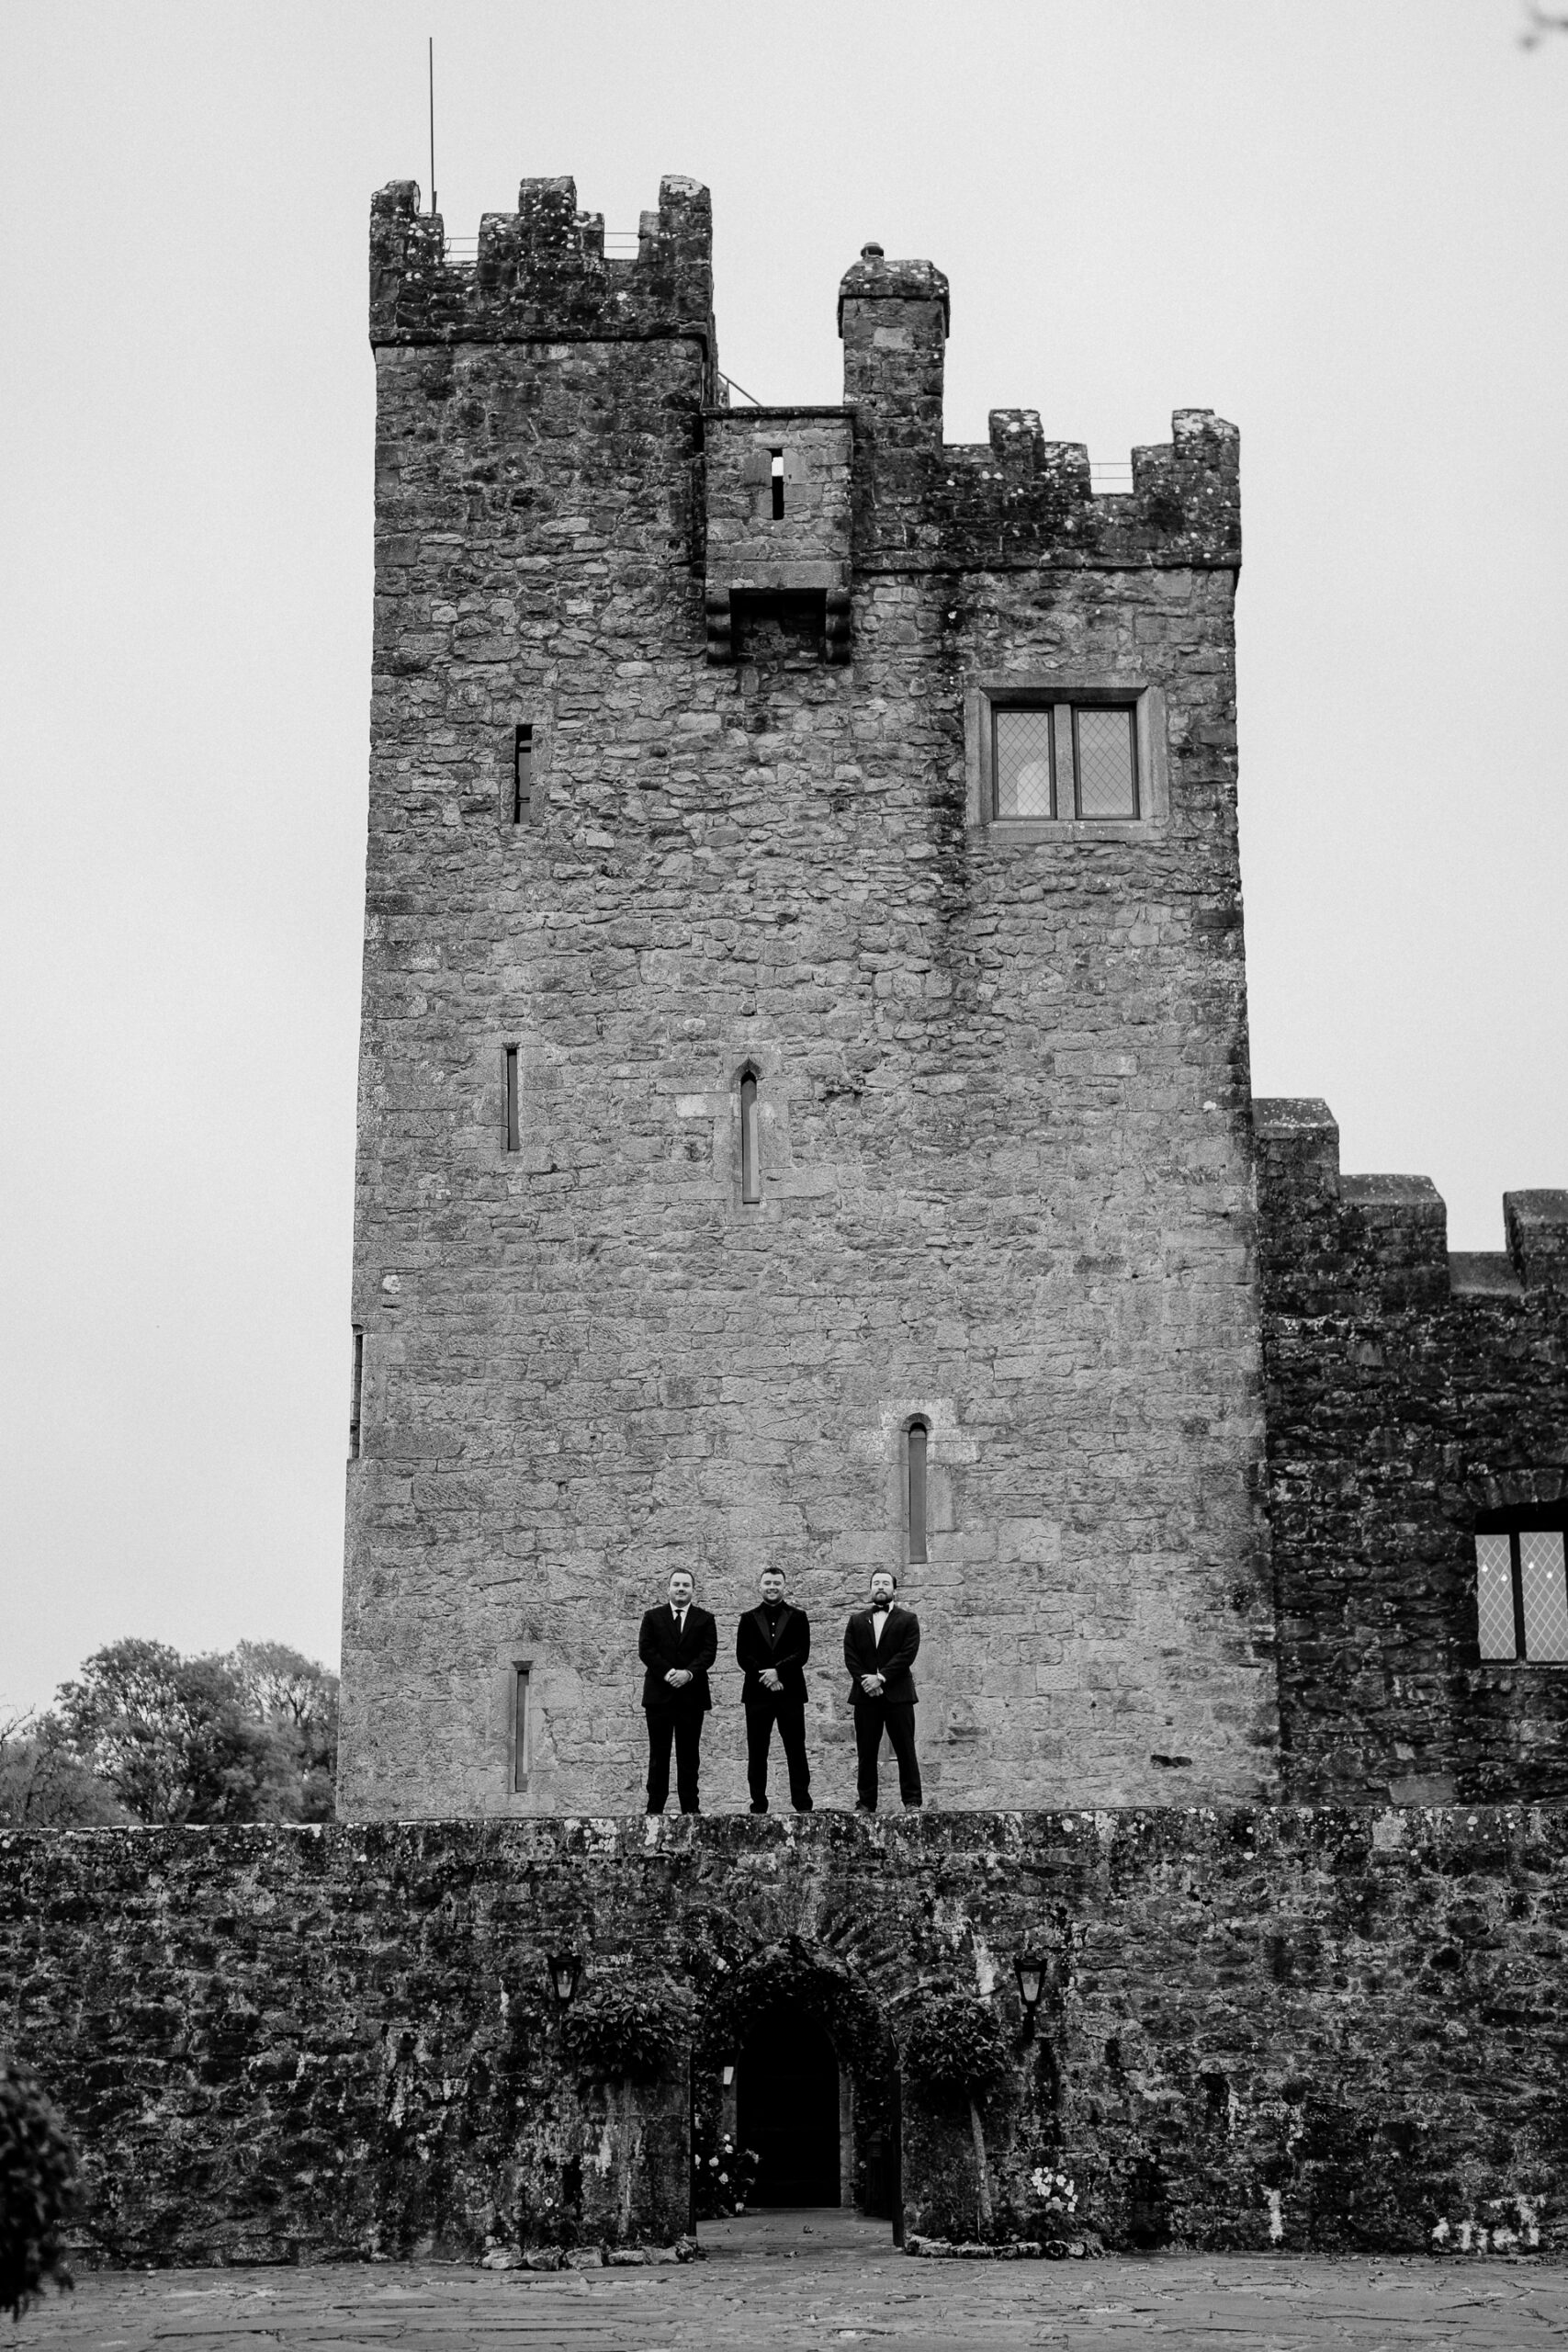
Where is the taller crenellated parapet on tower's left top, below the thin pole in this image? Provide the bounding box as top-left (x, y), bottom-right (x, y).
top-left (369, 176), bottom-right (715, 362)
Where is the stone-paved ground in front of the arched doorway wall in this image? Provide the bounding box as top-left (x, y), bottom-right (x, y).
top-left (12, 2213), bottom-right (1568, 2352)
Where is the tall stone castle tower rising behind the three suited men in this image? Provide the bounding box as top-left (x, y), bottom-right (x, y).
top-left (341, 179), bottom-right (1568, 1815)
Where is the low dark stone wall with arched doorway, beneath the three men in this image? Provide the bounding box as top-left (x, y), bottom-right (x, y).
top-left (0, 1809), bottom-right (1568, 2263)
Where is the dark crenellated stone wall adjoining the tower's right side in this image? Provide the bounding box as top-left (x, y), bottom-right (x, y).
top-left (1256, 1101), bottom-right (1568, 1802)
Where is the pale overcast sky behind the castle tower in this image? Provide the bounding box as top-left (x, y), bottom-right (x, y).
top-left (0, 0), bottom-right (1568, 1705)
